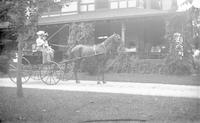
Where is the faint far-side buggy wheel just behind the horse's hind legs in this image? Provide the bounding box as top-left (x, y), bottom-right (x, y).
top-left (60, 62), bottom-right (74, 81)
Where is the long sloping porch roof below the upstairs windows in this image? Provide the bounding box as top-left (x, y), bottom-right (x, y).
top-left (39, 8), bottom-right (177, 25)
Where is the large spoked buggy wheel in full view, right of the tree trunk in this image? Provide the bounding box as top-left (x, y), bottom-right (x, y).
top-left (40, 61), bottom-right (63, 85)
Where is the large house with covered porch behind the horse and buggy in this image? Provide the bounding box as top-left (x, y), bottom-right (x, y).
top-left (39, 0), bottom-right (177, 56)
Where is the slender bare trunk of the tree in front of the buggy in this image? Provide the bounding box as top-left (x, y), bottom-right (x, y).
top-left (17, 35), bottom-right (23, 97)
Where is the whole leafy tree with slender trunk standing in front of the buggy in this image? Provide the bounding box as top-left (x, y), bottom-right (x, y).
top-left (0, 0), bottom-right (71, 97)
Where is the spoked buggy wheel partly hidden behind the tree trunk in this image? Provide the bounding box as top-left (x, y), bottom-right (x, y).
top-left (8, 57), bottom-right (32, 84)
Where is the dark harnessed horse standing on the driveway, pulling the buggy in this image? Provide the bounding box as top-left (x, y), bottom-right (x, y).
top-left (70, 33), bottom-right (122, 84)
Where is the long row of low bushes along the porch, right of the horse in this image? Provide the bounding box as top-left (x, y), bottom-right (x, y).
top-left (107, 54), bottom-right (193, 75)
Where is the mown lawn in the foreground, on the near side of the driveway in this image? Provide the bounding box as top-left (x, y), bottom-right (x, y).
top-left (0, 88), bottom-right (200, 123)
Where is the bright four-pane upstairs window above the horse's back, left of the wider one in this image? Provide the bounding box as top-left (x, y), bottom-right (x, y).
top-left (80, 0), bottom-right (95, 12)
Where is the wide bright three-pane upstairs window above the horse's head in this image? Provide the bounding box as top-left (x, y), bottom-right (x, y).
top-left (110, 0), bottom-right (138, 9)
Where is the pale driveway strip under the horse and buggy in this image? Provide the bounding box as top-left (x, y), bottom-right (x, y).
top-left (0, 78), bottom-right (200, 99)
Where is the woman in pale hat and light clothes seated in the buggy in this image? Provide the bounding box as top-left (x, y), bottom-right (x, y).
top-left (36, 31), bottom-right (54, 64)
